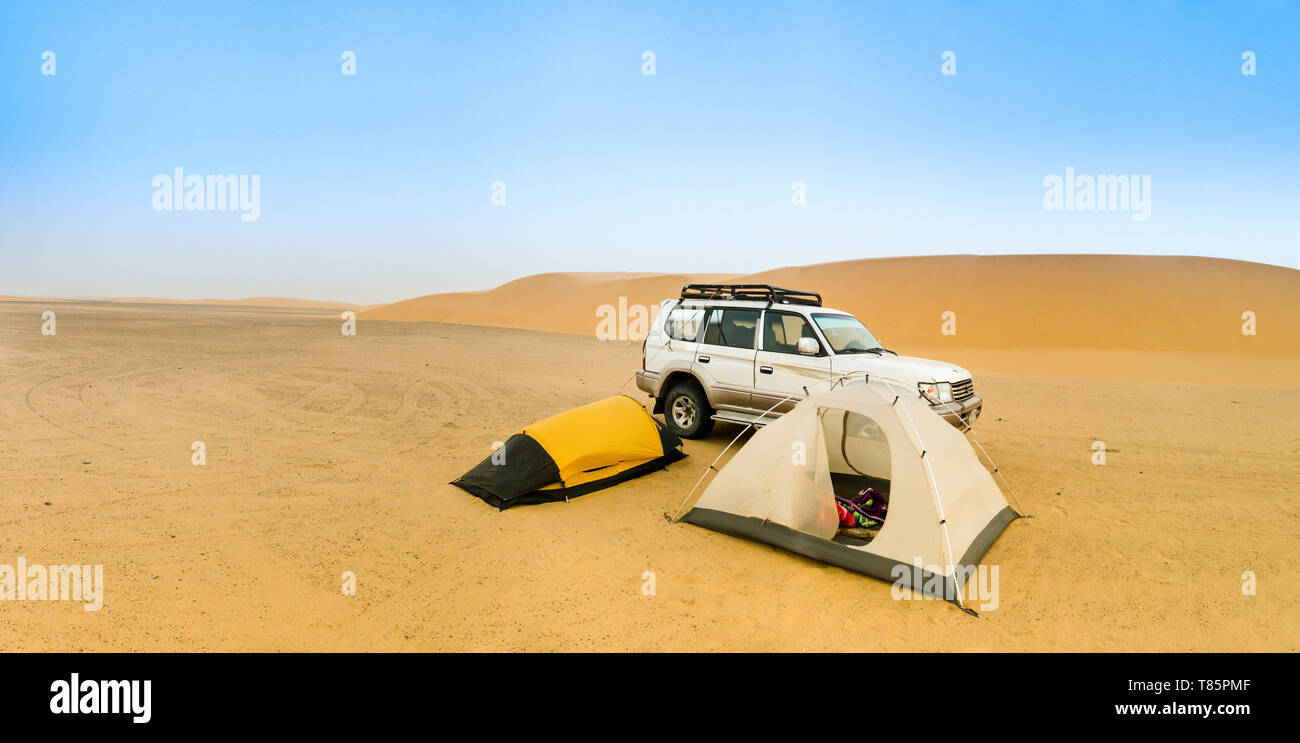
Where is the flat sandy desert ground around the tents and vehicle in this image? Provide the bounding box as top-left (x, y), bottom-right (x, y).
top-left (0, 301), bottom-right (1300, 651)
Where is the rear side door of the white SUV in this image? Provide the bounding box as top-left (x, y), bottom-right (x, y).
top-left (692, 307), bottom-right (762, 410)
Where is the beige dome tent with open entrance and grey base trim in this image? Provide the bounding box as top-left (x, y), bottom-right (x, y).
top-left (683, 377), bottom-right (1019, 611)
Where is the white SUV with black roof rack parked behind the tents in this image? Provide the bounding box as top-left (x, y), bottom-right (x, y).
top-left (637, 284), bottom-right (984, 439)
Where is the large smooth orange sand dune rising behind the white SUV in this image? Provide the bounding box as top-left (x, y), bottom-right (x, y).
top-left (361, 255), bottom-right (1300, 355)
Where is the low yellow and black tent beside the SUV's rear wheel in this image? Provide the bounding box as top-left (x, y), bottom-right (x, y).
top-left (451, 395), bottom-right (686, 510)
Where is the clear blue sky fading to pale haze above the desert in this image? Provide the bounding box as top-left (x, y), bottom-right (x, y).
top-left (0, 1), bottom-right (1300, 303)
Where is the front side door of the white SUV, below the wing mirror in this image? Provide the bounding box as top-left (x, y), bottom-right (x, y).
top-left (751, 309), bottom-right (831, 413)
